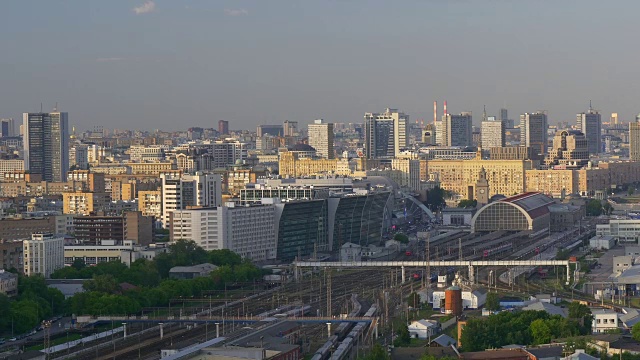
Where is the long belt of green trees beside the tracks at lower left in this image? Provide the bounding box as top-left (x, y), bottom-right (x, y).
top-left (0, 240), bottom-right (263, 334)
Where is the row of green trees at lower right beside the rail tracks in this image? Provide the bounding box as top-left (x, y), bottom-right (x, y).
top-left (461, 302), bottom-right (593, 351)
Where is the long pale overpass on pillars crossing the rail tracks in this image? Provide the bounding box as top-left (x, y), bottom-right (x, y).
top-left (293, 260), bottom-right (571, 285)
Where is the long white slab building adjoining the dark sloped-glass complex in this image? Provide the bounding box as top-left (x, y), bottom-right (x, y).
top-left (171, 203), bottom-right (277, 261)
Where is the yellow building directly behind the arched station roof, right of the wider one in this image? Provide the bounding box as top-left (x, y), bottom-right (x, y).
top-left (525, 170), bottom-right (579, 197)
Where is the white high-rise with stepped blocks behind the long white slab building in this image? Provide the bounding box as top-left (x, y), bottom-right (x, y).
top-left (160, 172), bottom-right (222, 228)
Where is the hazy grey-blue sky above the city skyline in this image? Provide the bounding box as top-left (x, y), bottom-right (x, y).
top-left (0, 0), bottom-right (640, 130)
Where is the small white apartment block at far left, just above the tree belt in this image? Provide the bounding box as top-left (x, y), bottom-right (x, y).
top-left (22, 233), bottom-right (64, 278)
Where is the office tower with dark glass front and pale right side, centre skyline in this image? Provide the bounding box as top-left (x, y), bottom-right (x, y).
top-left (364, 108), bottom-right (409, 159)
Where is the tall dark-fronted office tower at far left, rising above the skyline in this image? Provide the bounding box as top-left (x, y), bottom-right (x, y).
top-left (22, 112), bottom-right (69, 182)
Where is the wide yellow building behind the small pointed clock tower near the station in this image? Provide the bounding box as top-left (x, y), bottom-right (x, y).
top-left (427, 159), bottom-right (531, 199)
